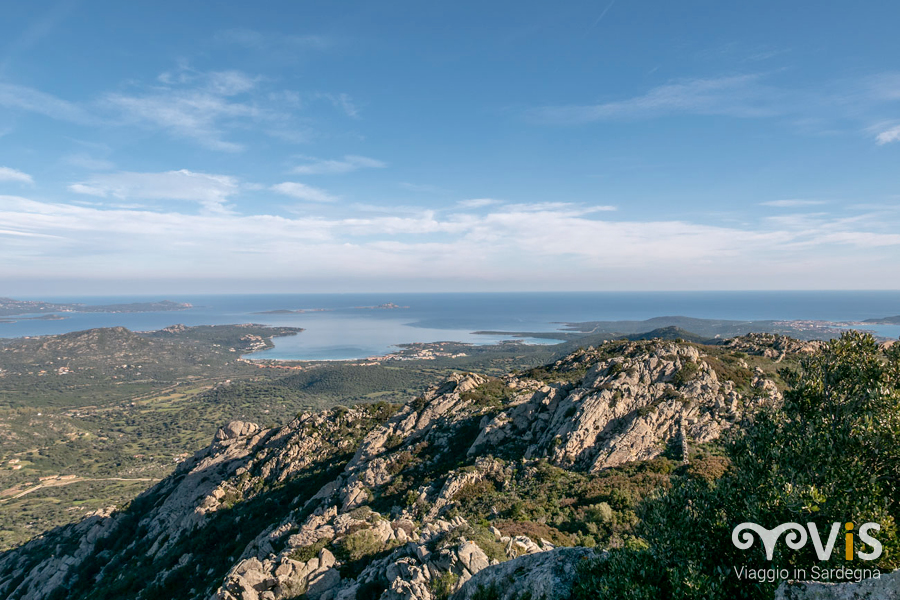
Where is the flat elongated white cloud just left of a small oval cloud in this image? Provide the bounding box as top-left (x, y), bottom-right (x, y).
top-left (69, 169), bottom-right (240, 214)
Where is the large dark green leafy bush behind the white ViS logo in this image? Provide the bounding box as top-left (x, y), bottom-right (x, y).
top-left (573, 332), bottom-right (900, 600)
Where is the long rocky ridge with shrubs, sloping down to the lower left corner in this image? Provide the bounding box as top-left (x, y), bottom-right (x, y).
top-left (0, 340), bottom-right (779, 600)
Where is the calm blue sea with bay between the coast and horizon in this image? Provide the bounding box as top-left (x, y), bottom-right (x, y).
top-left (0, 291), bottom-right (900, 360)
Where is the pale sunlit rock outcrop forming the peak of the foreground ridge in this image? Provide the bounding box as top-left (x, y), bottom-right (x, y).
top-left (469, 342), bottom-right (778, 471)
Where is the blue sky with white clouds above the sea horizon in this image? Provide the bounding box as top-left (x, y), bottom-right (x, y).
top-left (0, 0), bottom-right (900, 296)
